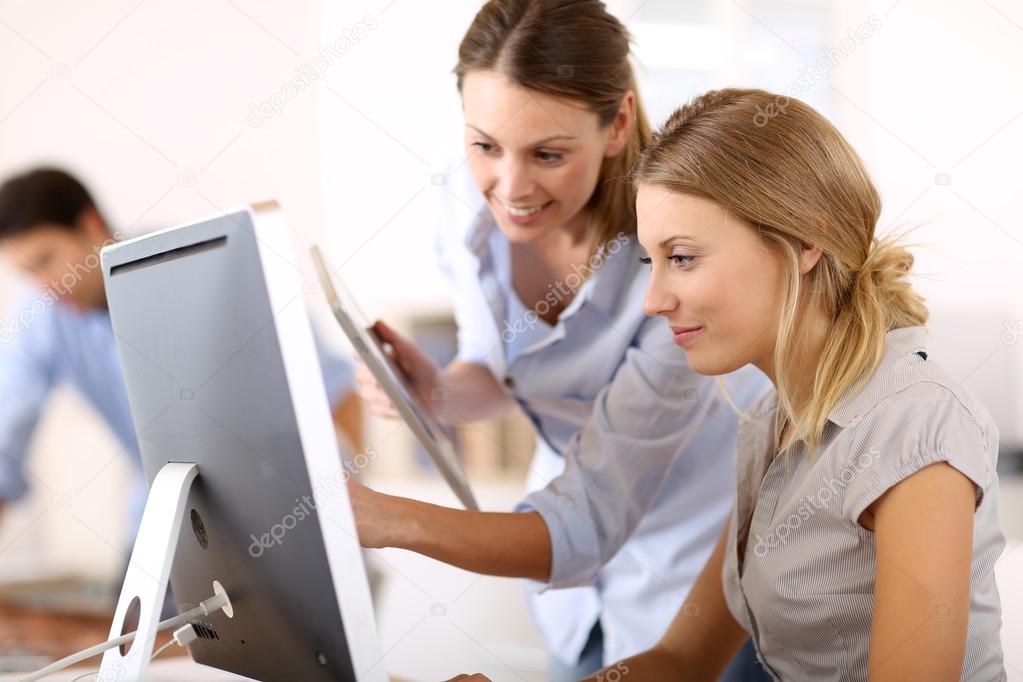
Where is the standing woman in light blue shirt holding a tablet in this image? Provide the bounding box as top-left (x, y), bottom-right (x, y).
top-left (351, 0), bottom-right (766, 680)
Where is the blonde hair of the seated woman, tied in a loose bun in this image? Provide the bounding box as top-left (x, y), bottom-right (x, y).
top-left (633, 89), bottom-right (928, 452)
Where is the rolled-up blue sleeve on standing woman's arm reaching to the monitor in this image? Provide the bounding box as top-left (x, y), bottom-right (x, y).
top-left (516, 319), bottom-right (738, 588)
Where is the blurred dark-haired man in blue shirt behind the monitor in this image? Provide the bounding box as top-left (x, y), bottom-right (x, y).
top-left (0, 169), bottom-right (361, 539)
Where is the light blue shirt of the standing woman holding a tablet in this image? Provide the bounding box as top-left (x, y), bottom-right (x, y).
top-left (438, 184), bottom-right (769, 664)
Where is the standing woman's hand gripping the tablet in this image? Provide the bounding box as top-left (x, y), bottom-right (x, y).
top-left (355, 320), bottom-right (443, 419)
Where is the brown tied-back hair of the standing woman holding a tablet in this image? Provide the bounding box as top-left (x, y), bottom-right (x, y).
top-left (454, 0), bottom-right (651, 253)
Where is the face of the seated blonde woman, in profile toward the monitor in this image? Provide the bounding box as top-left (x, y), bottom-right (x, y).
top-left (636, 185), bottom-right (785, 376)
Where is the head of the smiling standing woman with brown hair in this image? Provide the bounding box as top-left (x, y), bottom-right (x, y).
top-left (454, 2), bottom-right (651, 259)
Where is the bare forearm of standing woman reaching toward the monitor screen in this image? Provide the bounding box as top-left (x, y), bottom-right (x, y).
top-left (386, 490), bottom-right (550, 582)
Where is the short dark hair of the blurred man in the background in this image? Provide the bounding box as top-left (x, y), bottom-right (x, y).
top-left (0, 168), bottom-right (96, 238)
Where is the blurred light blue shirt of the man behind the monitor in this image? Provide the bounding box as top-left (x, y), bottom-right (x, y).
top-left (0, 292), bottom-right (354, 540)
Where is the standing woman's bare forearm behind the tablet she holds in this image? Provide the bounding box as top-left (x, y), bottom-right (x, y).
top-left (431, 360), bottom-right (515, 424)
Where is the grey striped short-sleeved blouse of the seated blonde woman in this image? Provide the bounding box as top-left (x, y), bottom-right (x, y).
top-left (722, 327), bottom-right (1006, 682)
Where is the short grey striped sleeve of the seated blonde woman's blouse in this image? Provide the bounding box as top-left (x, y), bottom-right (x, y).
top-left (833, 382), bottom-right (998, 522)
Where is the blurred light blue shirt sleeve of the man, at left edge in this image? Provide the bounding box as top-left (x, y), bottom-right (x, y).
top-left (0, 302), bottom-right (56, 501)
